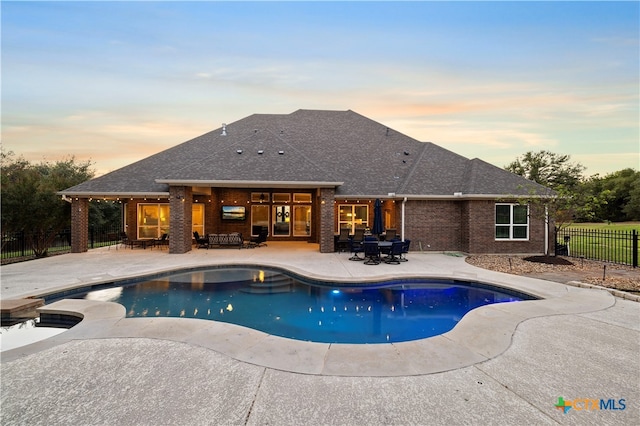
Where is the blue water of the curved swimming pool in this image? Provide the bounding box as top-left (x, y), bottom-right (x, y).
top-left (67, 267), bottom-right (532, 343)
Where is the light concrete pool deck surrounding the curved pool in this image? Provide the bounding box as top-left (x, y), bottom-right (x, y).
top-left (0, 242), bottom-right (640, 425)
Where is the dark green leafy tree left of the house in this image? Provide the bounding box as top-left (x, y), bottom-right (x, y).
top-left (1, 152), bottom-right (94, 257)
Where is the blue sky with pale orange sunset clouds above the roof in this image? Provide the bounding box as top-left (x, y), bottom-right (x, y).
top-left (0, 1), bottom-right (640, 176)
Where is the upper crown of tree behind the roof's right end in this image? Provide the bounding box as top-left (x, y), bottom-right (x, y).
top-left (505, 151), bottom-right (585, 191)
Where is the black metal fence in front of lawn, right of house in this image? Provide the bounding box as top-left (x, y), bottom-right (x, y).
top-left (556, 228), bottom-right (638, 268)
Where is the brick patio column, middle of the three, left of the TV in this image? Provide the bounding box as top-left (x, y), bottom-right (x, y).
top-left (169, 186), bottom-right (193, 254)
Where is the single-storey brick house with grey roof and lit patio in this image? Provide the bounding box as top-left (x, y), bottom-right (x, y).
top-left (60, 110), bottom-right (550, 253)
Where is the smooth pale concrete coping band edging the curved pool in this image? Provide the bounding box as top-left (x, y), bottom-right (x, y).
top-left (2, 262), bottom-right (615, 377)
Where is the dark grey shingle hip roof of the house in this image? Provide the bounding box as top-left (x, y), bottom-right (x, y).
top-left (61, 110), bottom-right (547, 198)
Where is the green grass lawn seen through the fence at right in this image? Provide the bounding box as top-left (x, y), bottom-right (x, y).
top-left (557, 222), bottom-right (640, 265)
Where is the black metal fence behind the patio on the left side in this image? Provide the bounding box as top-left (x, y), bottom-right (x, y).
top-left (0, 225), bottom-right (122, 261)
